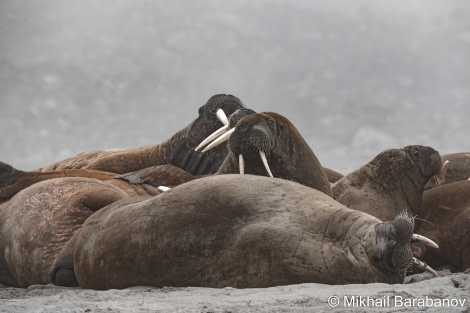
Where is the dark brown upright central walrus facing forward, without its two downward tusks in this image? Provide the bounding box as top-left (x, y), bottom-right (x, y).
top-left (218, 112), bottom-right (332, 196)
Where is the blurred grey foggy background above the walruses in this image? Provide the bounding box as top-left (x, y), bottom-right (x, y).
top-left (0, 0), bottom-right (470, 174)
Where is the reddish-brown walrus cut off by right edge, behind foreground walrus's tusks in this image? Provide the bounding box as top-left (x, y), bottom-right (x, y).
top-left (416, 180), bottom-right (470, 271)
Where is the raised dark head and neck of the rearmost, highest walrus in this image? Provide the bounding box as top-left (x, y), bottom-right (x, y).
top-left (170, 94), bottom-right (245, 175)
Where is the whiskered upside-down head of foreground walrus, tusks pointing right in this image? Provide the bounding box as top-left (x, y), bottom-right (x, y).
top-left (368, 212), bottom-right (438, 279)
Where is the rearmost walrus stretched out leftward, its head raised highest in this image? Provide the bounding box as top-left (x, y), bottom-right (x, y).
top-left (38, 94), bottom-right (245, 175)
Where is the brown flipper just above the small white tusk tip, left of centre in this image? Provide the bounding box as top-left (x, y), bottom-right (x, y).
top-left (115, 165), bottom-right (197, 187)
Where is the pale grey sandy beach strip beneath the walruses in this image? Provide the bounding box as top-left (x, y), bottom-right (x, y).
top-left (0, 270), bottom-right (470, 313)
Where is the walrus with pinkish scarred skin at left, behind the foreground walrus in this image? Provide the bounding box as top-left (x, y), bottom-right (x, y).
top-left (0, 177), bottom-right (149, 287)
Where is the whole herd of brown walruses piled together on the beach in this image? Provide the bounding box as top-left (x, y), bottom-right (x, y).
top-left (0, 94), bottom-right (470, 290)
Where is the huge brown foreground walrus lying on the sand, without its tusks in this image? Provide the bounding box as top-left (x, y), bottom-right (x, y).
top-left (51, 174), bottom-right (413, 289)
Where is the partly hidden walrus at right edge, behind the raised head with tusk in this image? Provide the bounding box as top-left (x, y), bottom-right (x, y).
top-left (424, 152), bottom-right (470, 190)
